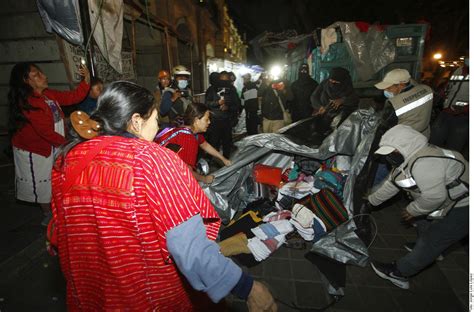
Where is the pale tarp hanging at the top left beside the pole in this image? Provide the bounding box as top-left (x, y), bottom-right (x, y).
top-left (36, 0), bottom-right (84, 45)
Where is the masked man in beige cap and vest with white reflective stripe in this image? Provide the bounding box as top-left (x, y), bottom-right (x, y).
top-left (375, 68), bottom-right (433, 137)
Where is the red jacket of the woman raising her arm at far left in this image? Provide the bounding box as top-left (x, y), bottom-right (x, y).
top-left (12, 80), bottom-right (90, 157)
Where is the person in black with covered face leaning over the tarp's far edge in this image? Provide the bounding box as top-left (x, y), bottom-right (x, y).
top-left (311, 67), bottom-right (359, 125)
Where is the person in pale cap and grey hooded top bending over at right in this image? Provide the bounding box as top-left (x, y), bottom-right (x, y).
top-left (368, 125), bottom-right (469, 289)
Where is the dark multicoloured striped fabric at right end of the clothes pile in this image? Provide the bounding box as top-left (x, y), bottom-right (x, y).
top-left (298, 189), bottom-right (348, 233)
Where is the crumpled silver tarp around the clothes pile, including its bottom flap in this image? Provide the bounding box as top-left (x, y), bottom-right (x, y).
top-left (203, 108), bottom-right (380, 266)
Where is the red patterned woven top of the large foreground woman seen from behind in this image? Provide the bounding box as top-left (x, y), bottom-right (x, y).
top-left (52, 137), bottom-right (220, 311)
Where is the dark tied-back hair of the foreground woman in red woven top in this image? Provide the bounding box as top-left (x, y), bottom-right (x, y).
top-left (58, 81), bottom-right (155, 159)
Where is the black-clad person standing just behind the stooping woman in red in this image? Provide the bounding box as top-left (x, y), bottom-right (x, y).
top-left (205, 72), bottom-right (241, 158)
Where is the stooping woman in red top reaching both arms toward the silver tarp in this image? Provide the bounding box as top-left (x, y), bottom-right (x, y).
top-left (155, 103), bottom-right (232, 184)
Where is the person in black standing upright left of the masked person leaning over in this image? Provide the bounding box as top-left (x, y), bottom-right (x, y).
top-left (290, 64), bottom-right (318, 122)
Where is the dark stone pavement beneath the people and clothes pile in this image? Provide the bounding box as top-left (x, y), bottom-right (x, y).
top-left (0, 151), bottom-right (469, 312)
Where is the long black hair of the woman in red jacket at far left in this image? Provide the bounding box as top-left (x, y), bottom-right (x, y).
top-left (8, 62), bottom-right (40, 136)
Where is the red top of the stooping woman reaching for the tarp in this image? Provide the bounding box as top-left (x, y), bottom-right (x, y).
top-left (156, 127), bottom-right (206, 168)
